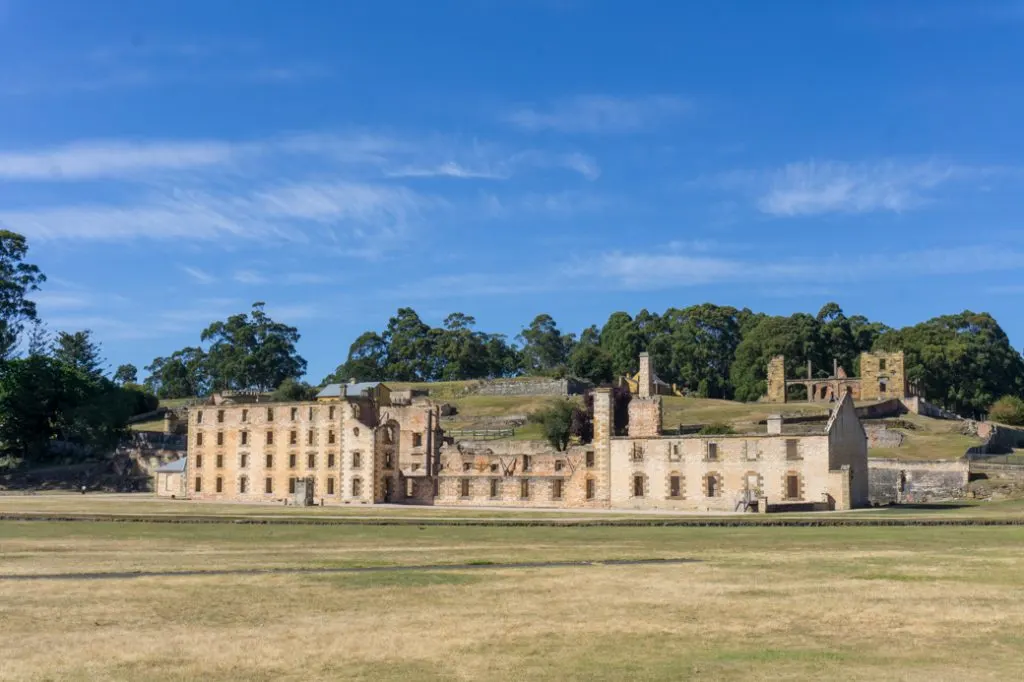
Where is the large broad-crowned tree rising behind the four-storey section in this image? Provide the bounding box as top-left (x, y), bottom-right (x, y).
top-left (200, 301), bottom-right (306, 391)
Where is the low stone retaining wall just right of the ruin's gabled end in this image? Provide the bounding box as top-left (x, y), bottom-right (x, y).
top-left (868, 458), bottom-right (970, 505)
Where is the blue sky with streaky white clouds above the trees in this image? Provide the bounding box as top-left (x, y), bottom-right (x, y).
top-left (0, 0), bottom-right (1024, 382)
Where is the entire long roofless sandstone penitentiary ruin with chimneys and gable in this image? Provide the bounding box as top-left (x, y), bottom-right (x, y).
top-left (184, 353), bottom-right (867, 511)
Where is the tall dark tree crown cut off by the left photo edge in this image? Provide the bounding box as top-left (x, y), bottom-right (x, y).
top-left (0, 229), bottom-right (46, 358)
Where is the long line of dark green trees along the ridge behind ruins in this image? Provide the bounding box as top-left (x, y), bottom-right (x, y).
top-left (146, 303), bottom-right (1024, 415)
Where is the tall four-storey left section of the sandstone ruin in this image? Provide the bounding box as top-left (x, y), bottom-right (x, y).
top-left (185, 384), bottom-right (440, 504)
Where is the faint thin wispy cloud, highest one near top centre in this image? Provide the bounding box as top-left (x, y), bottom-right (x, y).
top-left (505, 95), bottom-right (692, 134)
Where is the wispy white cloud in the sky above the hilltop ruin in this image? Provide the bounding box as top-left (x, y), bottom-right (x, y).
top-left (714, 159), bottom-right (1002, 216)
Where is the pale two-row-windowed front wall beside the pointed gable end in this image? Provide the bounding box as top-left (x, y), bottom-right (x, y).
top-left (611, 434), bottom-right (836, 511)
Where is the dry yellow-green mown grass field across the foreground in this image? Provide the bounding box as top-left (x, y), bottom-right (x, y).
top-left (0, 505), bottom-right (1024, 680)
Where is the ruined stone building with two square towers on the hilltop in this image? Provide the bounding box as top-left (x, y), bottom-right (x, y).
top-left (765, 350), bottom-right (921, 402)
